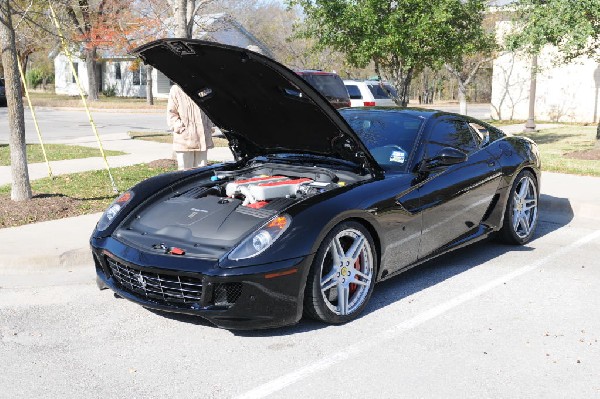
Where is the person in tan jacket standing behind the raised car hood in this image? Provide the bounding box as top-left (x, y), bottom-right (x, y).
top-left (167, 85), bottom-right (214, 170)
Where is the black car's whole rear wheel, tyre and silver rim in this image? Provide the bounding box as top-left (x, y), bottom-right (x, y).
top-left (501, 170), bottom-right (539, 245)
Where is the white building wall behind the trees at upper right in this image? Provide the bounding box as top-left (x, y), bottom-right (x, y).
top-left (491, 21), bottom-right (600, 123)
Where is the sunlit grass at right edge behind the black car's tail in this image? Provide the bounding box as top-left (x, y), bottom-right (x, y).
top-left (525, 126), bottom-right (600, 176)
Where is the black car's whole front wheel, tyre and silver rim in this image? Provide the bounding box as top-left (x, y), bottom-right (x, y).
top-left (304, 221), bottom-right (377, 324)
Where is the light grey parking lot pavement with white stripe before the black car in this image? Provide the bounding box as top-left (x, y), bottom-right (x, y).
top-left (0, 211), bottom-right (600, 398)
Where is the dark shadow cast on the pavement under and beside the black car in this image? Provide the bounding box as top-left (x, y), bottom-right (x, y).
top-left (149, 194), bottom-right (574, 337)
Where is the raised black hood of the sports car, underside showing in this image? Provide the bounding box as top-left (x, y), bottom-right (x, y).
top-left (134, 39), bottom-right (379, 171)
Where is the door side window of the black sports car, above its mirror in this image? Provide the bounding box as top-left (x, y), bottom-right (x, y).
top-left (425, 119), bottom-right (478, 157)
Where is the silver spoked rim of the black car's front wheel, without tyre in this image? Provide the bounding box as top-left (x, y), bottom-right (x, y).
top-left (320, 229), bottom-right (373, 316)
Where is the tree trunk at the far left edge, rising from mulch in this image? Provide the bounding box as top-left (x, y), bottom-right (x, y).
top-left (0, 0), bottom-right (32, 201)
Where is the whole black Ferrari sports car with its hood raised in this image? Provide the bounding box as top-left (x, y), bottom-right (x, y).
top-left (91, 39), bottom-right (540, 329)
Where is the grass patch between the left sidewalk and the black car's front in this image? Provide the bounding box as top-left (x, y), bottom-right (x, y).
top-left (0, 164), bottom-right (176, 215)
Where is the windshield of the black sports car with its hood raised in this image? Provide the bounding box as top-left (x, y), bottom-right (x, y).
top-left (340, 110), bottom-right (423, 172)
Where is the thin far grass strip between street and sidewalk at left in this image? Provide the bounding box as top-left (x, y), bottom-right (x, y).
top-left (0, 144), bottom-right (125, 166)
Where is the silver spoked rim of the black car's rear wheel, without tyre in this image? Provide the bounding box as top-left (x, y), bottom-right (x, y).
top-left (512, 175), bottom-right (537, 238)
